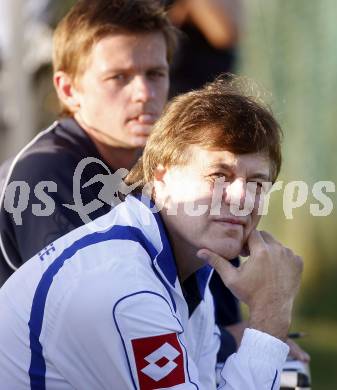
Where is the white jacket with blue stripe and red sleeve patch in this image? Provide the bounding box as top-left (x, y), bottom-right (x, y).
top-left (0, 196), bottom-right (288, 390)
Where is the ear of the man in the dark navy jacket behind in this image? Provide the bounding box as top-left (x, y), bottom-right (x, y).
top-left (53, 71), bottom-right (80, 112)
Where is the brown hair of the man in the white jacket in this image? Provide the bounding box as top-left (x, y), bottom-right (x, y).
top-left (126, 76), bottom-right (282, 186)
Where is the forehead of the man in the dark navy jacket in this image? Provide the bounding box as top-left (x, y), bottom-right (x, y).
top-left (84, 32), bottom-right (168, 72)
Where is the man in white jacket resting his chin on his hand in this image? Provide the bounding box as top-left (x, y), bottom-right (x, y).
top-left (0, 77), bottom-right (303, 390)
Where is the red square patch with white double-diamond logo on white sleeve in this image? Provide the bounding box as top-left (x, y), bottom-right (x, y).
top-left (132, 333), bottom-right (185, 390)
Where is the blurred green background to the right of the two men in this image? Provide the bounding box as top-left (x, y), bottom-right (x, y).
top-left (239, 0), bottom-right (337, 390)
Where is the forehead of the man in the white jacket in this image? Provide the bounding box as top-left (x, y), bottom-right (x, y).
top-left (187, 145), bottom-right (271, 179)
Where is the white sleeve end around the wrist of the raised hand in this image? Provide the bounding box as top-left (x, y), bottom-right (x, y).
top-left (219, 329), bottom-right (289, 390)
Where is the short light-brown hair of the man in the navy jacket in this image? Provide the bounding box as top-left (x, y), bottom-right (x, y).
top-left (53, 0), bottom-right (177, 113)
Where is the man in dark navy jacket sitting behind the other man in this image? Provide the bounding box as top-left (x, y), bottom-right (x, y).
top-left (0, 0), bottom-right (175, 285)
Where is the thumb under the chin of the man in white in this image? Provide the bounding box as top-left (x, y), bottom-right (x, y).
top-left (197, 249), bottom-right (239, 285)
